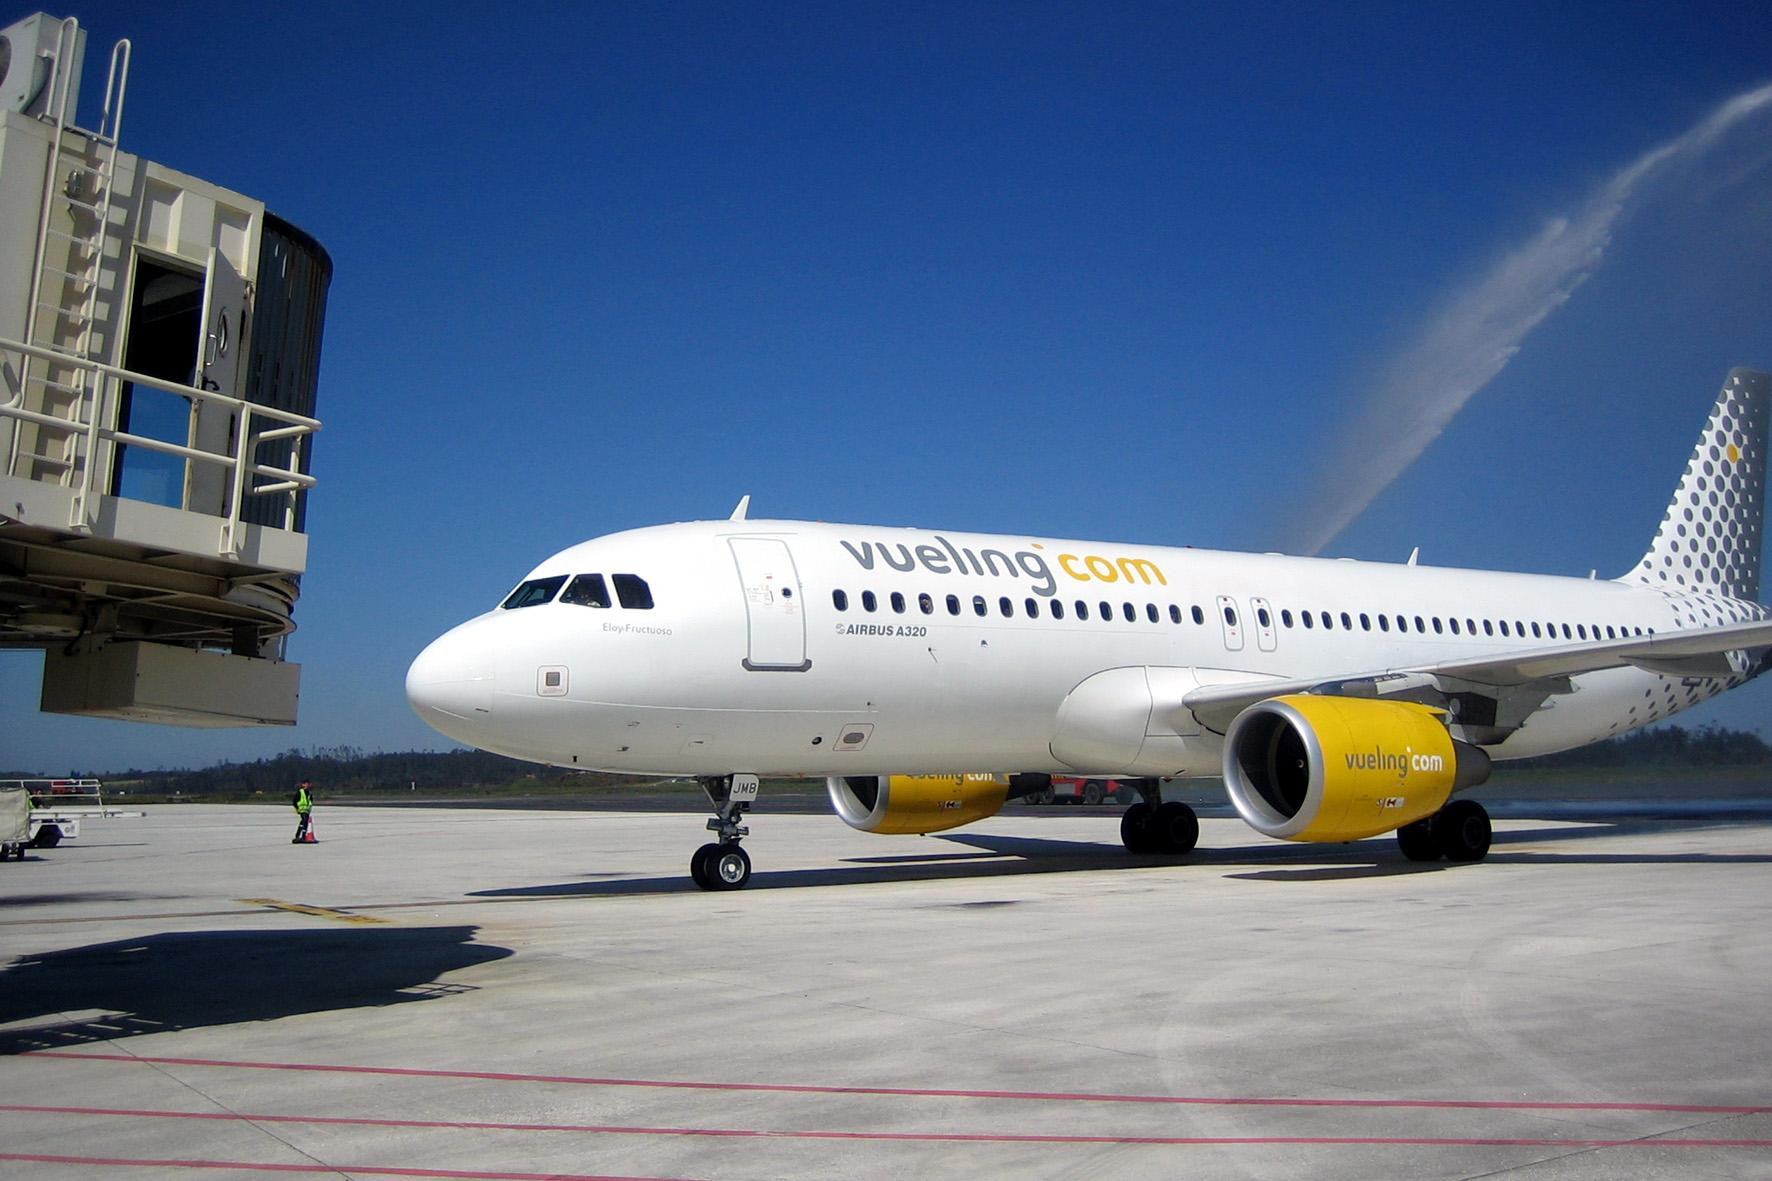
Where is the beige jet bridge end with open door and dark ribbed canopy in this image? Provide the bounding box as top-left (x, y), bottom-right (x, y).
top-left (0, 12), bottom-right (331, 725)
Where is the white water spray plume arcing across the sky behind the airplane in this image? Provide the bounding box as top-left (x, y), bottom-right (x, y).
top-left (1288, 83), bottom-right (1772, 553)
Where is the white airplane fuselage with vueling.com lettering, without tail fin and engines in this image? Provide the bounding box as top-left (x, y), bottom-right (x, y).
top-left (409, 521), bottom-right (1767, 775)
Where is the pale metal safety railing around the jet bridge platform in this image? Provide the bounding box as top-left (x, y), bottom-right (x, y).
top-left (0, 337), bottom-right (321, 557)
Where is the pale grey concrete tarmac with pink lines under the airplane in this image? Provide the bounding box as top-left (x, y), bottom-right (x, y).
top-left (0, 802), bottom-right (1772, 1181)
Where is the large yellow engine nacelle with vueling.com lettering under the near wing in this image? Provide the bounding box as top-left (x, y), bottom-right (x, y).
top-left (1224, 693), bottom-right (1490, 841)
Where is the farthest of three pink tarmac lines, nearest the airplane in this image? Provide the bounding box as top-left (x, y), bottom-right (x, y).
top-left (31, 1050), bottom-right (1772, 1115)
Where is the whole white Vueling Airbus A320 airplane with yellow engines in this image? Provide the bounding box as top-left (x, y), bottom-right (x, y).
top-left (406, 369), bottom-right (1772, 888)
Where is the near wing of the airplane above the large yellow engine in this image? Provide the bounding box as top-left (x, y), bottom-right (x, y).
top-left (1182, 621), bottom-right (1772, 743)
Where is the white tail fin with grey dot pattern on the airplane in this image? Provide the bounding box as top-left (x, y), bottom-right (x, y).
top-left (1620, 369), bottom-right (1772, 601)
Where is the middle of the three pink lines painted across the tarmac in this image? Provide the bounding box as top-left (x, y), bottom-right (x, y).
top-left (0, 1103), bottom-right (1772, 1141)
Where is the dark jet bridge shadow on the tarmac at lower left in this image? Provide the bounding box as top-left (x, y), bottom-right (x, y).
top-left (0, 926), bottom-right (512, 1055)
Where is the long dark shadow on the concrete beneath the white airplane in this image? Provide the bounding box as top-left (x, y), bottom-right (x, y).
top-left (468, 817), bottom-right (1772, 899)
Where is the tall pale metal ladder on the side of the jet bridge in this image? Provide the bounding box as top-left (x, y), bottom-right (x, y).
top-left (12, 18), bottom-right (131, 528)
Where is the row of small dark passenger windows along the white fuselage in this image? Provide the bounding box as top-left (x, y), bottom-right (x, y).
top-left (831, 591), bottom-right (1655, 640)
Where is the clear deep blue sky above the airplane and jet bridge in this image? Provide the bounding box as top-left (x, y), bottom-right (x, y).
top-left (0, 2), bottom-right (1772, 773)
